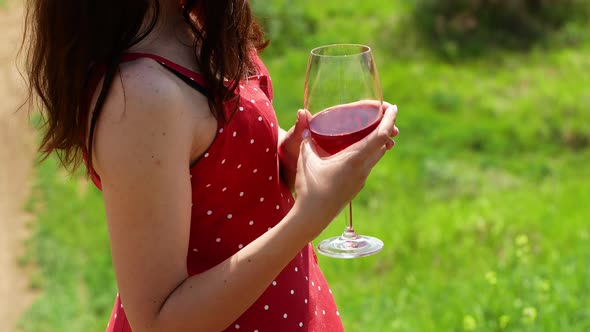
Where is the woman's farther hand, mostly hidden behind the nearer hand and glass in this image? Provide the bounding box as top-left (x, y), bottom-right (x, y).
top-left (279, 110), bottom-right (311, 191)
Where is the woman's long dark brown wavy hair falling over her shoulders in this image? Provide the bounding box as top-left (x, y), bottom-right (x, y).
top-left (23, 0), bottom-right (266, 170)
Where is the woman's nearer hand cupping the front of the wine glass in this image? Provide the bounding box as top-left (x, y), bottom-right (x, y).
top-left (295, 105), bottom-right (399, 237)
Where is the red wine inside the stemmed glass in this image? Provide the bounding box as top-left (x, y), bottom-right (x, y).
top-left (309, 103), bottom-right (381, 154)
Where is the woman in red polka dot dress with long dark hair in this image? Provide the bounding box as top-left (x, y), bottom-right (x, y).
top-left (26, 0), bottom-right (398, 332)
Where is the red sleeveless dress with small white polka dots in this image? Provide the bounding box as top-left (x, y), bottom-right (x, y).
top-left (93, 53), bottom-right (343, 332)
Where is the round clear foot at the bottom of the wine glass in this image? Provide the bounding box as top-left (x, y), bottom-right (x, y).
top-left (317, 231), bottom-right (383, 258)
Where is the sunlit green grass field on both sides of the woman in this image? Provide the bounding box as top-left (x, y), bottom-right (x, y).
top-left (21, 0), bottom-right (590, 332)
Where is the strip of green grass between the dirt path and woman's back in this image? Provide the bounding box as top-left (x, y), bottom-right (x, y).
top-left (20, 158), bottom-right (116, 332)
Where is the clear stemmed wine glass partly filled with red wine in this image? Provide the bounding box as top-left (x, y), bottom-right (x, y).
top-left (304, 44), bottom-right (383, 258)
